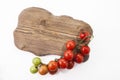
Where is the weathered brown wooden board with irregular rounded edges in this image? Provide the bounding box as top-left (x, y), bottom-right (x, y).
top-left (14, 7), bottom-right (92, 55)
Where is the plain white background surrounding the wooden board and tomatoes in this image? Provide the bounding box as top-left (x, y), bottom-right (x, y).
top-left (0, 0), bottom-right (120, 80)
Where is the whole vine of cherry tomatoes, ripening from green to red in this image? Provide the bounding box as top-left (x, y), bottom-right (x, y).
top-left (30, 32), bottom-right (90, 75)
